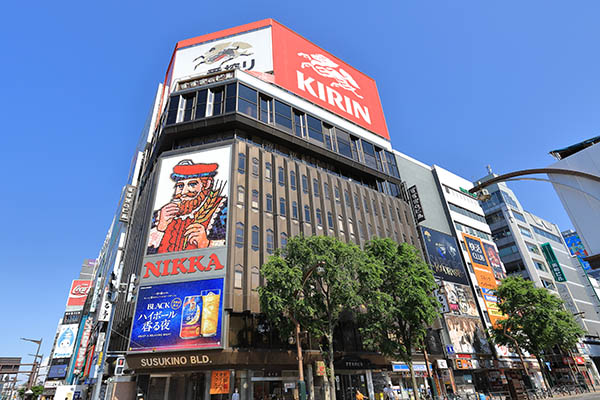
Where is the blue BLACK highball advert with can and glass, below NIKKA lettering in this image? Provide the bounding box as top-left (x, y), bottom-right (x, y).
top-left (129, 278), bottom-right (223, 351)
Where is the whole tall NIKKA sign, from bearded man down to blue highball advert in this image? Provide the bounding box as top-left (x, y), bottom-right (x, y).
top-left (129, 146), bottom-right (231, 351)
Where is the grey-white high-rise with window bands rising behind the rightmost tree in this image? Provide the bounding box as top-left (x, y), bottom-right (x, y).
top-left (479, 173), bottom-right (600, 383)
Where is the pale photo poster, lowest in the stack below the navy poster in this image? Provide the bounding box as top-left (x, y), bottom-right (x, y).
top-left (445, 315), bottom-right (490, 354)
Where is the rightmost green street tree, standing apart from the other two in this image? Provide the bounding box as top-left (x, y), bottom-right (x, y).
top-left (492, 277), bottom-right (585, 387)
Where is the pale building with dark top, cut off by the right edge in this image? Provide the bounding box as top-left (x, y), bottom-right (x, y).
top-left (548, 136), bottom-right (600, 269)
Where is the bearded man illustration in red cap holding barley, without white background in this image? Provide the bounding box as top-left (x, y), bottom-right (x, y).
top-left (148, 160), bottom-right (227, 254)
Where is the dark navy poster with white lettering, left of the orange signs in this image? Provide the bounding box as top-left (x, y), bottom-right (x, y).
top-left (421, 227), bottom-right (469, 285)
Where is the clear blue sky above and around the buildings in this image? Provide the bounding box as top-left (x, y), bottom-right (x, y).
top-left (0, 1), bottom-right (600, 372)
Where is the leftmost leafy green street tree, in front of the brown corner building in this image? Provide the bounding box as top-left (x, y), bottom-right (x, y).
top-left (259, 236), bottom-right (369, 400)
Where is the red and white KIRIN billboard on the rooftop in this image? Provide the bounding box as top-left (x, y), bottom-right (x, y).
top-left (166, 19), bottom-right (390, 140)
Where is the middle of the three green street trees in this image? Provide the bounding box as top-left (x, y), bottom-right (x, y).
top-left (361, 239), bottom-right (440, 399)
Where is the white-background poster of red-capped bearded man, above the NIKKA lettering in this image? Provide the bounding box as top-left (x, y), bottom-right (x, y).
top-left (147, 146), bottom-right (231, 255)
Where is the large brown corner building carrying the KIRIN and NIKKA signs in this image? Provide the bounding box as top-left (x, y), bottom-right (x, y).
top-left (77, 19), bottom-right (426, 400)
